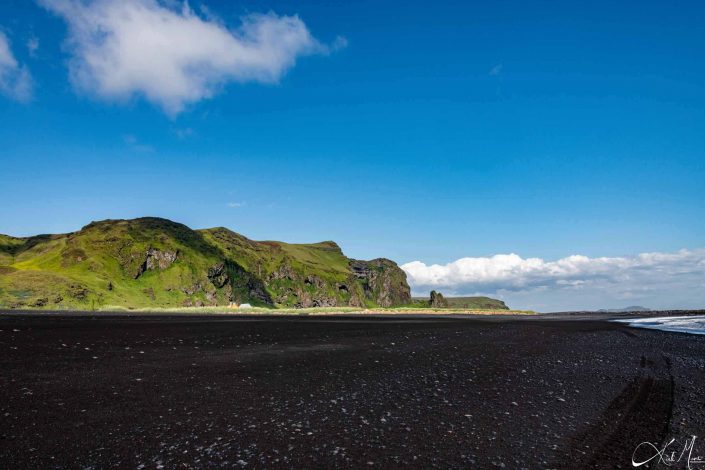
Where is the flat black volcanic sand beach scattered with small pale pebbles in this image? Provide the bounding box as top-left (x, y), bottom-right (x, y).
top-left (0, 315), bottom-right (705, 468)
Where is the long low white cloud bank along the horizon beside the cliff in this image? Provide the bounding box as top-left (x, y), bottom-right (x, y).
top-left (402, 249), bottom-right (705, 310)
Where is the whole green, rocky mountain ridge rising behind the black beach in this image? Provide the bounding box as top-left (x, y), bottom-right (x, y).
top-left (0, 217), bottom-right (410, 309)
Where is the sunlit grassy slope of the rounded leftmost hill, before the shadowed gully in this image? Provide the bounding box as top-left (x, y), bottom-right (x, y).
top-left (0, 218), bottom-right (227, 309)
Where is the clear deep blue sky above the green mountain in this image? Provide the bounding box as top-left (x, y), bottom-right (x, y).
top-left (0, 0), bottom-right (705, 309)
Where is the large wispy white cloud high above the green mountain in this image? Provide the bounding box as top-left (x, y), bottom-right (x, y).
top-left (40, 0), bottom-right (329, 115)
